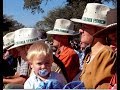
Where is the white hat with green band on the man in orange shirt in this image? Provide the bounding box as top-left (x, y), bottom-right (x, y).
top-left (46, 19), bottom-right (79, 35)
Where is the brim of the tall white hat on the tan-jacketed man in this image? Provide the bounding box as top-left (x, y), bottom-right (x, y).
top-left (70, 18), bottom-right (106, 27)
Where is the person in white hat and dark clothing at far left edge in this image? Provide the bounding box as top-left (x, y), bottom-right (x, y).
top-left (1, 32), bottom-right (17, 77)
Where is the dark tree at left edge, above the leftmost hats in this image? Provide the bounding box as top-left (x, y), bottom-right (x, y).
top-left (3, 15), bottom-right (25, 35)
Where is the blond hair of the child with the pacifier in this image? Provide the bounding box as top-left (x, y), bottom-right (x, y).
top-left (26, 41), bottom-right (53, 61)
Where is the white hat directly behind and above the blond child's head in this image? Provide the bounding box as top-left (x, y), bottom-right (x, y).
top-left (9, 28), bottom-right (39, 49)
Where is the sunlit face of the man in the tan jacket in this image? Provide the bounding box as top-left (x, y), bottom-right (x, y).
top-left (79, 24), bottom-right (95, 44)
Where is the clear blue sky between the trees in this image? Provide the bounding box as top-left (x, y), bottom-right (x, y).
top-left (3, 0), bottom-right (115, 27)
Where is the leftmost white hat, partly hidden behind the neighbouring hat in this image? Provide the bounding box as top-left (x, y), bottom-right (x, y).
top-left (3, 32), bottom-right (15, 49)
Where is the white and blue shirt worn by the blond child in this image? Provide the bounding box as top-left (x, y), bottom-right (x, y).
top-left (24, 72), bottom-right (65, 89)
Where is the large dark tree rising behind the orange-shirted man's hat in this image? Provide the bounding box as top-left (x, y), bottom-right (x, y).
top-left (35, 0), bottom-right (116, 31)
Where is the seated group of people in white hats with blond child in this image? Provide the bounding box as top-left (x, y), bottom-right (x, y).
top-left (3, 3), bottom-right (117, 89)
